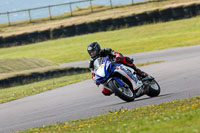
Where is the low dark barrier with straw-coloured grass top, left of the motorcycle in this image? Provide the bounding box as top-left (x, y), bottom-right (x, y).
top-left (0, 66), bottom-right (89, 89)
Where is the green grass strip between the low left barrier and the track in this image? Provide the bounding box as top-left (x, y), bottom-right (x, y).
top-left (0, 73), bottom-right (91, 104)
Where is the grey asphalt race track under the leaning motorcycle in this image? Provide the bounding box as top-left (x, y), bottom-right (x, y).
top-left (0, 45), bottom-right (200, 133)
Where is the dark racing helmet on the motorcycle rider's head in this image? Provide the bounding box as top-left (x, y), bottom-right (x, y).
top-left (87, 42), bottom-right (101, 59)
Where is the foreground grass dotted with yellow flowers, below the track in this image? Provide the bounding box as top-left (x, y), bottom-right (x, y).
top-left (19, 97), bottom-right (200, 133)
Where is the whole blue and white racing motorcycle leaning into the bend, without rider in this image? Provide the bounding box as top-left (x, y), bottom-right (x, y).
top-left (94, 57), bottom-right (160, 102)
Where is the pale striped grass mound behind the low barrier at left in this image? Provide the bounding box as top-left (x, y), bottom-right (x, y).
top-left (0, 58), bottom-right (58, 74)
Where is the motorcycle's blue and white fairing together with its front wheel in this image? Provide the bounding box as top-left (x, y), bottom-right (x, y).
top-left (94, 57), bottom-right (147, 101)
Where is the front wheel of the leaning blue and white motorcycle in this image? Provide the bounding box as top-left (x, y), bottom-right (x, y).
top-left (109, 79), bottom-right (135, 102)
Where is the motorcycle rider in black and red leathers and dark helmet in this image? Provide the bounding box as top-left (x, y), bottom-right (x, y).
top-left (87, 42), bottom-right (147, 96)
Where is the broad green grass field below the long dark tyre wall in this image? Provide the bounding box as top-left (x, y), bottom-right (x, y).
top-left (0, 17), bottom-right (200, 63)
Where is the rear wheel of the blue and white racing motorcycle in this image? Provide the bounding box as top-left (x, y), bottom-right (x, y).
top-left (147, 80), bottom-right (160, 97)
